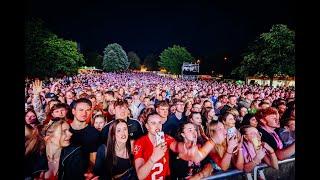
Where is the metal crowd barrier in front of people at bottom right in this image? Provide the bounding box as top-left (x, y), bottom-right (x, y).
top-left (203, 158), bottom-right (295, 180)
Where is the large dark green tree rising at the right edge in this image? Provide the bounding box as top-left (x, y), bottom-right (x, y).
top-left (232, 24), bottom-right (295, 86)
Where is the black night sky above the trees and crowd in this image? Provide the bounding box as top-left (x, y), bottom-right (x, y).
top-left (26, 0), bottom-right (296, 74)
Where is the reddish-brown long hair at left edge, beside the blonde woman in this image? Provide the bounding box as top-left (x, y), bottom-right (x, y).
top-left (24, 123), bottom-right (45, 156)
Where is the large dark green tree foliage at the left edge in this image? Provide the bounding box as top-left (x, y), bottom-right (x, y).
top-left (25, 19), bottom-right (85, 77)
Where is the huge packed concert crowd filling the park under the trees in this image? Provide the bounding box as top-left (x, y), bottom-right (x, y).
top-left (24, 73), bottom-right (295, 180)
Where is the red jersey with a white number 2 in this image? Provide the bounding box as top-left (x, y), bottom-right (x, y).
top-left (133, 134), bottom-right (175, 180)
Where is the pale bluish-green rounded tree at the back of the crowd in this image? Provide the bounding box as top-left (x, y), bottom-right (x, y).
top-left (102, 43), bottom-right (130, 72)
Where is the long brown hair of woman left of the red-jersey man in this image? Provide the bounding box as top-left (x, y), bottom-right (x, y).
top-left (106, 119), bottom-right (133, 176)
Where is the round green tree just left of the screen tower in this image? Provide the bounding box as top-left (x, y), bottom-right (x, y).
top-left (158, 45), bottom-right (194, 74)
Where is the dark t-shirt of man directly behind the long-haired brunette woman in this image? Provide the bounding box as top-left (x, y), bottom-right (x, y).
top-left (101, 119), bottom-right (144, 142)
